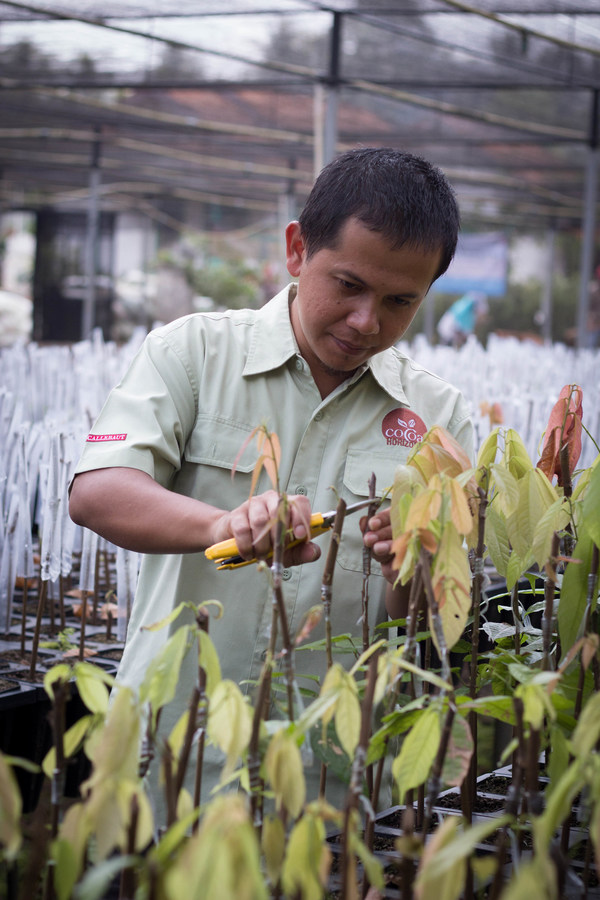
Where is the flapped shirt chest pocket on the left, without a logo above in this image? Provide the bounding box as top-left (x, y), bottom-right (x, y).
top-left (174, 415), bottom-right (266, 509)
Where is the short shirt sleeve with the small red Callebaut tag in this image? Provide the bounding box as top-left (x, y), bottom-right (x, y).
top-left (75, 332), bottom-right (196, 487)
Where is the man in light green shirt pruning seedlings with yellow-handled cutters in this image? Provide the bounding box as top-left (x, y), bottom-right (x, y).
top-left (70, 149), bottom-right (471, 808)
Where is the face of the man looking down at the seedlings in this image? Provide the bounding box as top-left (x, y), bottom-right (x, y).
top-left (286, 218), bottom-right (441, 396)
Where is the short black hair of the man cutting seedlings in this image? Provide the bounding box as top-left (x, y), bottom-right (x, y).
top-left (299, 147), bottom-right (460, 278)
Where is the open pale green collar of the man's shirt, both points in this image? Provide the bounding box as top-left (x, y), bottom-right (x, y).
top-left (243, 284), bottom-right (408, 406)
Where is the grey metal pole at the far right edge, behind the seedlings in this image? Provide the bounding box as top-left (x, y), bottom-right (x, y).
top-left (577, 90), bottom-right (600, 348)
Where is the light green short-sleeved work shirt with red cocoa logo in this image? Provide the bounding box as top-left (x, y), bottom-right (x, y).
top-left (76, 285), bottom-right (472, 800)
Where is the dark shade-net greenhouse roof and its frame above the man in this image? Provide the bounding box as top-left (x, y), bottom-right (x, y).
top-left (0, 0), bottom-right (600, 344)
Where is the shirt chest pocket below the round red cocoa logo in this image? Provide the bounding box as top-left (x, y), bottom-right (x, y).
top-left (337, 447), bottom-right (410, 575)
